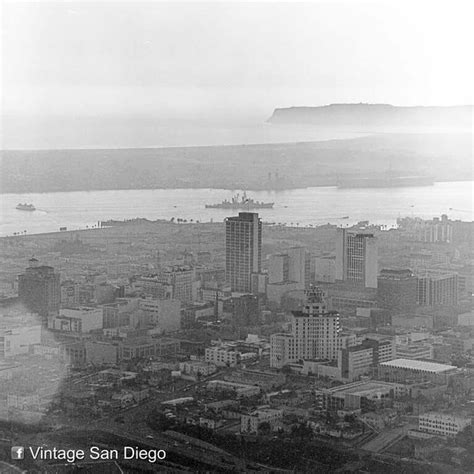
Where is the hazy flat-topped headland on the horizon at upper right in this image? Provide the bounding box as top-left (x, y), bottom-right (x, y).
top-left (267, 103), bottom-right (473, 128)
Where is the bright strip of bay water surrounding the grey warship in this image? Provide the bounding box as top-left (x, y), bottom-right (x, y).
top-left (0, 181), bottom-right (474, 236)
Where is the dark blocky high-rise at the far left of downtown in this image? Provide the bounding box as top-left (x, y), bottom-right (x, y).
top-left (18, 258), bottom-right (61, 317)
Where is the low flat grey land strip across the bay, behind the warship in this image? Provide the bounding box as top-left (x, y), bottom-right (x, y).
top-left (0, 133), bottom-right (474, 194)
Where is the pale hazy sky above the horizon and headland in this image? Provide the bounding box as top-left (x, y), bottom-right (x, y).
top-left (1, 0), bottom-right (474, 148)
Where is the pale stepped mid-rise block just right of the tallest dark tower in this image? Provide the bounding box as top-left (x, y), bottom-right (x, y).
top-left (268, 247), bottom-right (310, 290)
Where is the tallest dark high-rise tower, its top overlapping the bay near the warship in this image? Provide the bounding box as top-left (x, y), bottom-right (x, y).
top-left (225, 212), bottom-right (262, 293)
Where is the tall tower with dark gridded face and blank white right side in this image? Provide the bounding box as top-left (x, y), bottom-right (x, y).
top-left (336, 229), bottom-right (377, 288)
